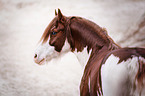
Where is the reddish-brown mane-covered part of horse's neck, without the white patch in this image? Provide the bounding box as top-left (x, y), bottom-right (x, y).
top-left (66, 16), bottom-right (118, 51)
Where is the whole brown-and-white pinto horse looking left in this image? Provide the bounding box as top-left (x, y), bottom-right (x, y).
top-left (34, 9), bottom-right (145, 96)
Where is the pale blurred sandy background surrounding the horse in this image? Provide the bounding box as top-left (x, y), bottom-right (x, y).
top-left (0, 0), bottom-right (145, 96)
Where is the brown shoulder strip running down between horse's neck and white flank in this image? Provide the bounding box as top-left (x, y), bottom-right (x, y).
top-left (80, 46), bottom-right (112, 96)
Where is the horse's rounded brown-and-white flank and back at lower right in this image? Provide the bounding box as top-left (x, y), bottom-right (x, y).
top-left (101, 48), bottom-right (145, 96)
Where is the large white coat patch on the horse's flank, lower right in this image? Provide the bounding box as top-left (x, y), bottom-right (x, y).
top-left (101, 55), bottom-right (138, 96)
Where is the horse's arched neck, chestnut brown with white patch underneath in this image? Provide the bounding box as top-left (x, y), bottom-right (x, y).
top-left (67, 17), bottom-right (118, 66)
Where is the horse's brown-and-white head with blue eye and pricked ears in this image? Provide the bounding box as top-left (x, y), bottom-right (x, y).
top-left (34, 9), bottom-right (70, 64)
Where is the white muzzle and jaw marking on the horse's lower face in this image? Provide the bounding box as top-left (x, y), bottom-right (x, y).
top-left (34, 39), bottom-right (71, 65)
